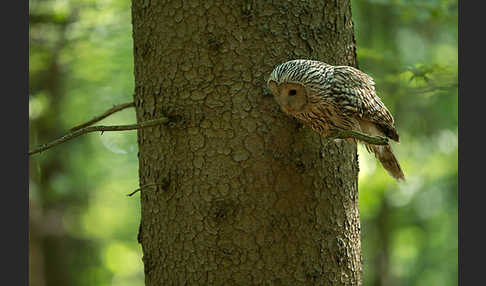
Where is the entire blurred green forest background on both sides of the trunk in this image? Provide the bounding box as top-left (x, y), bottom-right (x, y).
top-left (29, 0), bottom-right (458, 286)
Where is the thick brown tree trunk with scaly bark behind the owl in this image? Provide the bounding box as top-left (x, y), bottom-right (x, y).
top-left (132, 0), bottom-right (361, 285)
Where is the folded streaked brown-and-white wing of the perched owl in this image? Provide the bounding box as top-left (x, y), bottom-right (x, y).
top-left (329, 66), bottom-right (399, 141)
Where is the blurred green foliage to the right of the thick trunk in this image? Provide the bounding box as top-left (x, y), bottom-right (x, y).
top-left (352, 0), bottom-right (458, 285)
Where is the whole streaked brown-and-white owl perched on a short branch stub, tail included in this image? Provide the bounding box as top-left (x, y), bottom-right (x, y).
top-left (267, 60), bottom-right (405, 180)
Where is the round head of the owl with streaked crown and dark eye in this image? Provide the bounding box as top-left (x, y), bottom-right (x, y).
top-left (267, 60), bottom-right (323, 115)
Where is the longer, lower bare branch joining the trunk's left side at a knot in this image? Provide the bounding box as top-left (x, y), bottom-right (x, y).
top-left (29, 117), bottom-right (169, 156)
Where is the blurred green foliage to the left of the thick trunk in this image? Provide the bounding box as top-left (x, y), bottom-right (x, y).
top-left (29, 0), bottom-right (140, 285)
